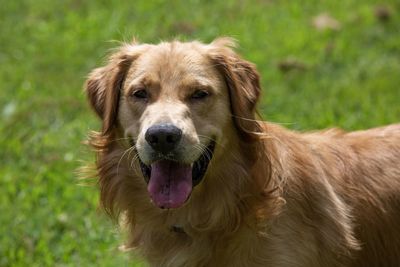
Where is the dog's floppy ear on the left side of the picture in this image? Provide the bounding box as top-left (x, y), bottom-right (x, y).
top-left (85, 43), bottom-right (144, 134)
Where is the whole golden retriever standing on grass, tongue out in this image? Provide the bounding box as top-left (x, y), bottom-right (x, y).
top-left (85, 37), bottom-right (400, 267)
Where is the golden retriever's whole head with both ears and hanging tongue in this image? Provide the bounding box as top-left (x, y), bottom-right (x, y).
top-left (86, 38), bottom-right (260, 208)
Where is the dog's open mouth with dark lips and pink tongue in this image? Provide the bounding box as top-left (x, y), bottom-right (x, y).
top-left (139, 141), bottom-right (215, 209)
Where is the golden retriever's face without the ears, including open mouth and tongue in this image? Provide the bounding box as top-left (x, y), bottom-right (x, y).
top-left (118, 44), bottom-right (230, 208)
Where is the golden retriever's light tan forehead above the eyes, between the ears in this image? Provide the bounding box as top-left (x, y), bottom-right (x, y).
top-left (130, 42), bottom-right (217, 86)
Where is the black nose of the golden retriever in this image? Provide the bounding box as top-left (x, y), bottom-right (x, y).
top-left (145, 123), bottom-right (182, 154)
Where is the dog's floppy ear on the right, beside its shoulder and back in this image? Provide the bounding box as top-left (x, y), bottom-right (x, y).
top-left (209, 38), bottom-right (261, 141)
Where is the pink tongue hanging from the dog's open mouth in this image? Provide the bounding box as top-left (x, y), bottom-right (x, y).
top-left (147, 160), bottom-right (192, 209)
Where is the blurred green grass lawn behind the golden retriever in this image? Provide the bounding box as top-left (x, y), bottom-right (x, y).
top-left (0, 0), bottom-right (400, 266)
